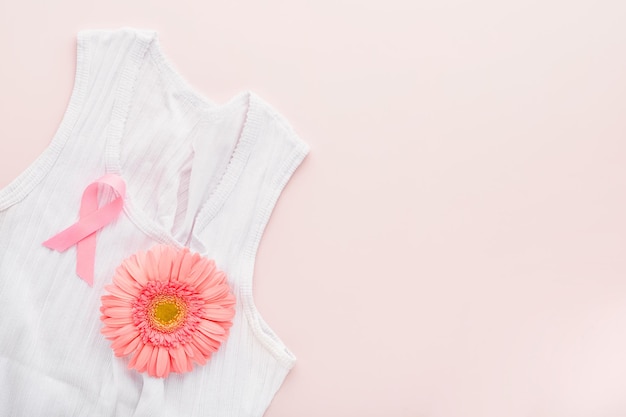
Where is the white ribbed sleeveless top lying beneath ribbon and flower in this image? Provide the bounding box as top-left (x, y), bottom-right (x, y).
top-left (0, 28), bottom-right (308, 417)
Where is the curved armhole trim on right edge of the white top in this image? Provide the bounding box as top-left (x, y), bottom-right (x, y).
top-left (241, 132), bottom-right (309, 369)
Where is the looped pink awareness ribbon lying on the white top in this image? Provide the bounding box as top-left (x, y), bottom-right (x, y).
top-left (43, 174), bottom-right (126, 287)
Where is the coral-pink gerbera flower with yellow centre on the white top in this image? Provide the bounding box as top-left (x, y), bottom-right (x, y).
top-left (100, 245), bottom-right (235, 378)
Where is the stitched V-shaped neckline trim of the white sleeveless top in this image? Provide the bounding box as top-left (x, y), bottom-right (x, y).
top-left (105, 28), bottom-right (261, 247)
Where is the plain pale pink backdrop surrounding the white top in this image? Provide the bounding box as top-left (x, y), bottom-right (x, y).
top-left (0, 0), bottom-right (626, 417)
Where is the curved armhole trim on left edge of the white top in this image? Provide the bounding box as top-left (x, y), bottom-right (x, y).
top-left (0, 32), bottom-right (91, 211)
